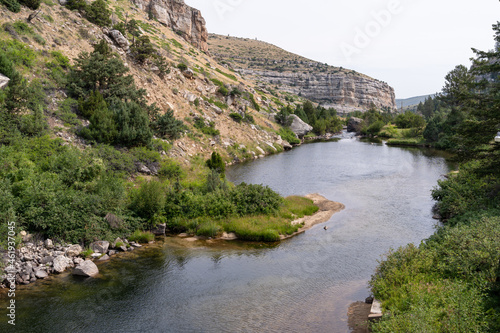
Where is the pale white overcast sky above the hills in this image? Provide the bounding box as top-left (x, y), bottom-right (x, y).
top-left (185, 0), bottom-right (500, 98)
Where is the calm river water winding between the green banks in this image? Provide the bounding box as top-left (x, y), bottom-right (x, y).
top-left (0, 137), bottom-right (451, 332)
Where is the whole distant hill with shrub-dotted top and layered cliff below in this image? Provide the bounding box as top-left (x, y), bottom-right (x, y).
top-left (209, 34), bottom-right (396, 112)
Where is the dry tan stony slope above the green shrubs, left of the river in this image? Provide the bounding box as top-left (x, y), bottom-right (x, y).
top-left (0, 0), bottom-right (308, 165)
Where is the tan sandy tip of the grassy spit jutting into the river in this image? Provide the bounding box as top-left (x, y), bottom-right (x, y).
top-left (280, 193), bottom-right (345, 240)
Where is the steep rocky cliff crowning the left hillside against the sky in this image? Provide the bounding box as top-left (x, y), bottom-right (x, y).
top-left (133, 0), bottom-right (208, 52)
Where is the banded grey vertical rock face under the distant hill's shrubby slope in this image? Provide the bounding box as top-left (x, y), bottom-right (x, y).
top-left (239, 69), bottom-right (397, 112)
